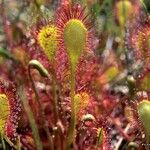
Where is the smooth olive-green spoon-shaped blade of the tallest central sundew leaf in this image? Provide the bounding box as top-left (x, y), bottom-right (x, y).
top-left (64, 19), bottom-right (87, 69)
